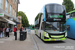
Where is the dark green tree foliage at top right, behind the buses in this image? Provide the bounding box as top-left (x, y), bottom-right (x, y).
top-left (62, 0), bottom-right (74, 12)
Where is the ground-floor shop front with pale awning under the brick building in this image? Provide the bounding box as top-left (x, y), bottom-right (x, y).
top-left (0, 15), bottom-right (16, 32)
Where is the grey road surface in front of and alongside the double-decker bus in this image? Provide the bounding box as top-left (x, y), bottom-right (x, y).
top-left (31, 30), bottom-right (75, 50)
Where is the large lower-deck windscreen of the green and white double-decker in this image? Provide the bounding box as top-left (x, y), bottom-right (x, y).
top-left (45, 22), bottom-right (66, 33)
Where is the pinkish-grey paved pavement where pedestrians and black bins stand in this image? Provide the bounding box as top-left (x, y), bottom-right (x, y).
top-left (0, 31), bottom-right (34, 50)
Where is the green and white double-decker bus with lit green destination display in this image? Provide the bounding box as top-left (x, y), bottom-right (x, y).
top-left (35, 3), bottom-right (67, 41)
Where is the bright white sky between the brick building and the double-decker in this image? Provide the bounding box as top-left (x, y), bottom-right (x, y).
top-left (18, 0), bottom-right (75, 25)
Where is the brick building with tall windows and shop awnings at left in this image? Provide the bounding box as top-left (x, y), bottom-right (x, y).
top-left (0, 0), bottom-right (20, 30)
